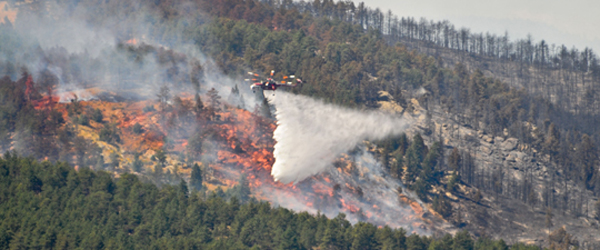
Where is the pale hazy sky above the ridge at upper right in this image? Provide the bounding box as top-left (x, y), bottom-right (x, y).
top-left (355, 0), bottom-right (600, 54)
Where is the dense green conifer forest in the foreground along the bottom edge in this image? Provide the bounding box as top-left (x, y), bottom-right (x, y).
top-left (0, 153), bottom-right (538, 250)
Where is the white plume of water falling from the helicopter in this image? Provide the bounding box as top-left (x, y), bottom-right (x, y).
top-left (269, 92), bottom-right (410, 183)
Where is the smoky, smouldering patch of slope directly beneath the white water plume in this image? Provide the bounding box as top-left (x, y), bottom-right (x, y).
top-left (254, 146), bottom-right (436, 235)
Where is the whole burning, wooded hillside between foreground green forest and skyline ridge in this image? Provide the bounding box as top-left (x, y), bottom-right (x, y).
top-left (0, 0), bottom-right (600, 249)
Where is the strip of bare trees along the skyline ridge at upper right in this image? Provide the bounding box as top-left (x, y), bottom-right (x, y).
top-left (198, 0), bottom-right (600, 80)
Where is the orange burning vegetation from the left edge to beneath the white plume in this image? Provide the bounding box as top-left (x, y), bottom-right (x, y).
top-left (1, 63), bottom-right (440, 233)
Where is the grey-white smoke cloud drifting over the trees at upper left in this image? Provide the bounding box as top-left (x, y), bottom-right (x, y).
top-left (0, 1), bottom-right (260, 106)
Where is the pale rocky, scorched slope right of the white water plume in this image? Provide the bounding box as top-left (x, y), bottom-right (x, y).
top-left (380, 93), bottom-right (600, 249)
